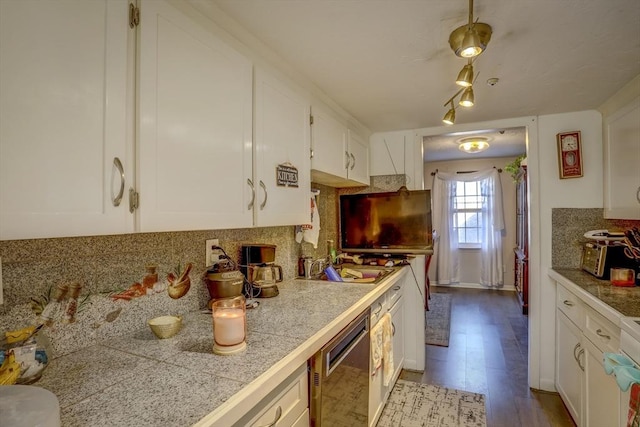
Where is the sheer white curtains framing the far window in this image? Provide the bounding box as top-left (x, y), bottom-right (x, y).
top-left (432, 168), bottom-right (505, 288)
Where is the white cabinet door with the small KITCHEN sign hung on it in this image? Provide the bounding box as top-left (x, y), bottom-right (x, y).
top-left (254, 70), bottom-right (311, 226)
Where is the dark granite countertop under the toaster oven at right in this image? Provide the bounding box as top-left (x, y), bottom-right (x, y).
top-left (552, 268), bottom-right (640, 317)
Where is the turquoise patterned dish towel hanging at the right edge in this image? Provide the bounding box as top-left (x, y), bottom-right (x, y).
top-left (602, 353), bottom-right (640, 427)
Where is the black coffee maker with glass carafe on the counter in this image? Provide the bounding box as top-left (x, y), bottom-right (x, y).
top-left (240, 244), bottom-right (282, 298)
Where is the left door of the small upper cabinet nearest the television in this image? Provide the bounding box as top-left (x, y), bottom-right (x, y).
top-left (311, 107), bottom-right (349, 179)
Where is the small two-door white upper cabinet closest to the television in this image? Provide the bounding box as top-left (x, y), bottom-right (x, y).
top-left (311, 106), bottom-right (369, 187)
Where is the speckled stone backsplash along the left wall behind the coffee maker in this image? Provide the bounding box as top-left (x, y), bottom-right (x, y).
top-left (0, 176), bottom-right (404, 356)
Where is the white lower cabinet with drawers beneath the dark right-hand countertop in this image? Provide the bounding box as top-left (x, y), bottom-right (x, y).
top-left (556, 283), bottom-right (621, 427)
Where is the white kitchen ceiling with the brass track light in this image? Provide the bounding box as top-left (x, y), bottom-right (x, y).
top-left (202, 0), bottom-right (640, 160)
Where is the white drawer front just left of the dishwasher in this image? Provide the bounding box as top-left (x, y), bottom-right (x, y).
top-left (250, 369), bottom-right (309, 427)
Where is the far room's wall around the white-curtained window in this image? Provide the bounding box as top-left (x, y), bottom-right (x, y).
top-left (424, 157), bottom-right (516, 290)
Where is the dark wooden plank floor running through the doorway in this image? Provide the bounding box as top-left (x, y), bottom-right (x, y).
top-left (401, 287), bottom-right (575, 427)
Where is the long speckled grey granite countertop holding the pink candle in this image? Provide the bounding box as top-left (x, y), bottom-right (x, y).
top-left (35, 269), bottom-right (403, 427)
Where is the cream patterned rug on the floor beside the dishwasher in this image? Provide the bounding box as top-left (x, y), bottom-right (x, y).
top-left (377, 380), bottom-right (487, 427)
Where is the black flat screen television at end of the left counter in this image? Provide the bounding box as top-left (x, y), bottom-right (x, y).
top-left (340, 190), bottom-right (433, 254)
